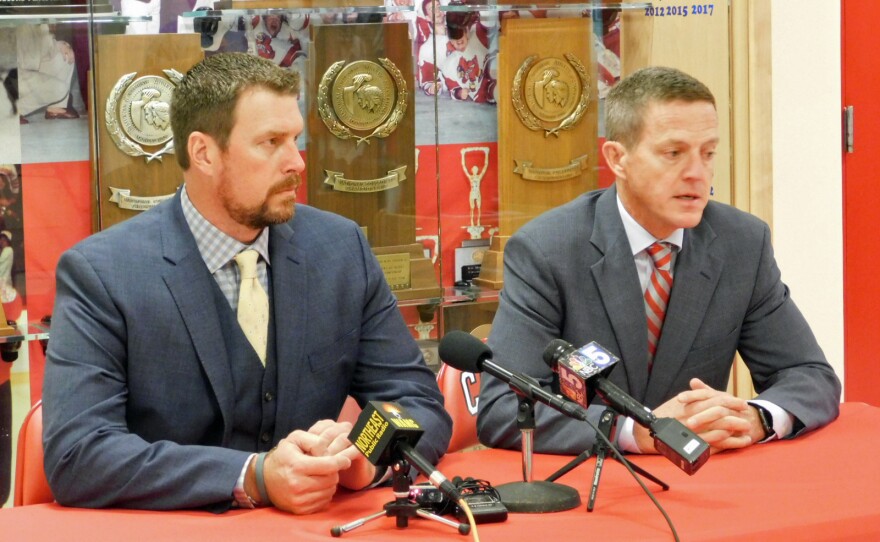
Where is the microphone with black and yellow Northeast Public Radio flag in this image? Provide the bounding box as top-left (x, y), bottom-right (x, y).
top-left (348, 401), bottom-right (461, 502)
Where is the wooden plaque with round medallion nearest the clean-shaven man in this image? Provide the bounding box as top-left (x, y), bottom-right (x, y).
top-left (498, 19), bottom-right (599, 236)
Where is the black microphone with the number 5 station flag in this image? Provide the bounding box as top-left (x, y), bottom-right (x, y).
top-left (544, 339), bottom-right (709, 474)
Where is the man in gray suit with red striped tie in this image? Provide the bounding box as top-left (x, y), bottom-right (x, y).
top-left (478, 68), bottom-right (840, 460)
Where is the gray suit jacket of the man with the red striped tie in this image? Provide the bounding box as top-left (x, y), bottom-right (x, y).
top-left (478, 186), bottom-right (840, 453)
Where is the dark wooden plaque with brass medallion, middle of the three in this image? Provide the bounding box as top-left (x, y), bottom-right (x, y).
top-left (306, 22), bottom-right (416, 247)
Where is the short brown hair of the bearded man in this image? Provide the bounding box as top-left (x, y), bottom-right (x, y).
top-left (171, 53), bottom-right (299, 171)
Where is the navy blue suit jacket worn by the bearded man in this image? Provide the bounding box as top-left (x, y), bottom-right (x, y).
top-left (43, 195), bottom-right (451, 509)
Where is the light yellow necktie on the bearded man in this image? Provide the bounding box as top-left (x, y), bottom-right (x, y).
top-left (235, 249), bottom-right (269, 366)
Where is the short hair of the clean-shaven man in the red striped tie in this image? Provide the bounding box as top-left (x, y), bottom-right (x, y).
top-left (605, 66), bottom-right (715, 148)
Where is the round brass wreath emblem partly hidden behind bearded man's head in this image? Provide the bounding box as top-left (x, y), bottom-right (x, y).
top-left (104, 69), bottom-right (183, 162)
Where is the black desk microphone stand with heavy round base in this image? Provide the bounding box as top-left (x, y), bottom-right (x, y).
top-left (495, 396), bottom-right (581, 513)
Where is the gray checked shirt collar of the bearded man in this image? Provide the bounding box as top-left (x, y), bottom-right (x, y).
top-left (180, 184), bottom-right (270, 274)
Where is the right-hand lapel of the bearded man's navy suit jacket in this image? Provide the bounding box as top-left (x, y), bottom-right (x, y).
top-left (269, 220), bottom-right (310, 438)
